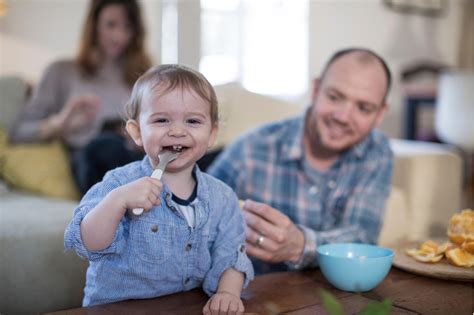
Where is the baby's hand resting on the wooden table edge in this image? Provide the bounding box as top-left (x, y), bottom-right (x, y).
top-left (202, 291), bottom-right (245, 315)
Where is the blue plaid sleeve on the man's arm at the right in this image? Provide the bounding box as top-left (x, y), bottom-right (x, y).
top-left (287, 146), bottom-right (393, 270)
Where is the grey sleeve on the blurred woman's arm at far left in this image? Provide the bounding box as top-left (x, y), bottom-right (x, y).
top-left (10, 62), bottom-right (67, 143)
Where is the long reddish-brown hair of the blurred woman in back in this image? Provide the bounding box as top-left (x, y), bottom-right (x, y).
top-left (76, 0), bottom-right (151, 86)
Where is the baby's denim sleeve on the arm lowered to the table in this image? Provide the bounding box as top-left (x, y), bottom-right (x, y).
top-left (203, 191), bottom-right (254, 295)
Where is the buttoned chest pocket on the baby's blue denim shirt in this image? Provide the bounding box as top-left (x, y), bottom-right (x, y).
top-left (130, 219), bottom-right (174, 263)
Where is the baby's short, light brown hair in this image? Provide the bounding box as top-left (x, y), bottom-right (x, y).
top-left (125, 64), bottom-right (219, 126)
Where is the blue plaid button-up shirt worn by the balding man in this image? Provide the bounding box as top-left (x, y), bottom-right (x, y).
top-left (208, 117), bottom-right (393, 273)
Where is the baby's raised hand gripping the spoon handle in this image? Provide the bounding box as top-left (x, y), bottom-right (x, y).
top-left (115, 177), bottom-right (163, 215)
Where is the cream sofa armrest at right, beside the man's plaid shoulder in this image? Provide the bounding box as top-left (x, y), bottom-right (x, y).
top-left (391, 139), bottom-right (462, 239)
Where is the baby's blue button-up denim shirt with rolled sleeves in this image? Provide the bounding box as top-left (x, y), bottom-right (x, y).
top-left (64, 156), bottom-right (253, 306)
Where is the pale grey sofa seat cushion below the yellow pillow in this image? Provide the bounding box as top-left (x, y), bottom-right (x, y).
top-left (0, 191), bottom-right (88, 314)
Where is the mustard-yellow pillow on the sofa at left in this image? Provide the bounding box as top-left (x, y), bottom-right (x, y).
top-left (0, 129), bottom-right (80, 200)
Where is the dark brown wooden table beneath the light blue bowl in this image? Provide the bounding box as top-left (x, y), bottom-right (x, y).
top-left (50, 267), bottom-right (474, 315)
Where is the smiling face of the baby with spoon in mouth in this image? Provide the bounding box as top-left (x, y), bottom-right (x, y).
top-left (139, 87), bottom-right (217, 172)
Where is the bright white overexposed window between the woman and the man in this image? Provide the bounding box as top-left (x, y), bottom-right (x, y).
top-left (163, 0), bottom-right (309, 99)
